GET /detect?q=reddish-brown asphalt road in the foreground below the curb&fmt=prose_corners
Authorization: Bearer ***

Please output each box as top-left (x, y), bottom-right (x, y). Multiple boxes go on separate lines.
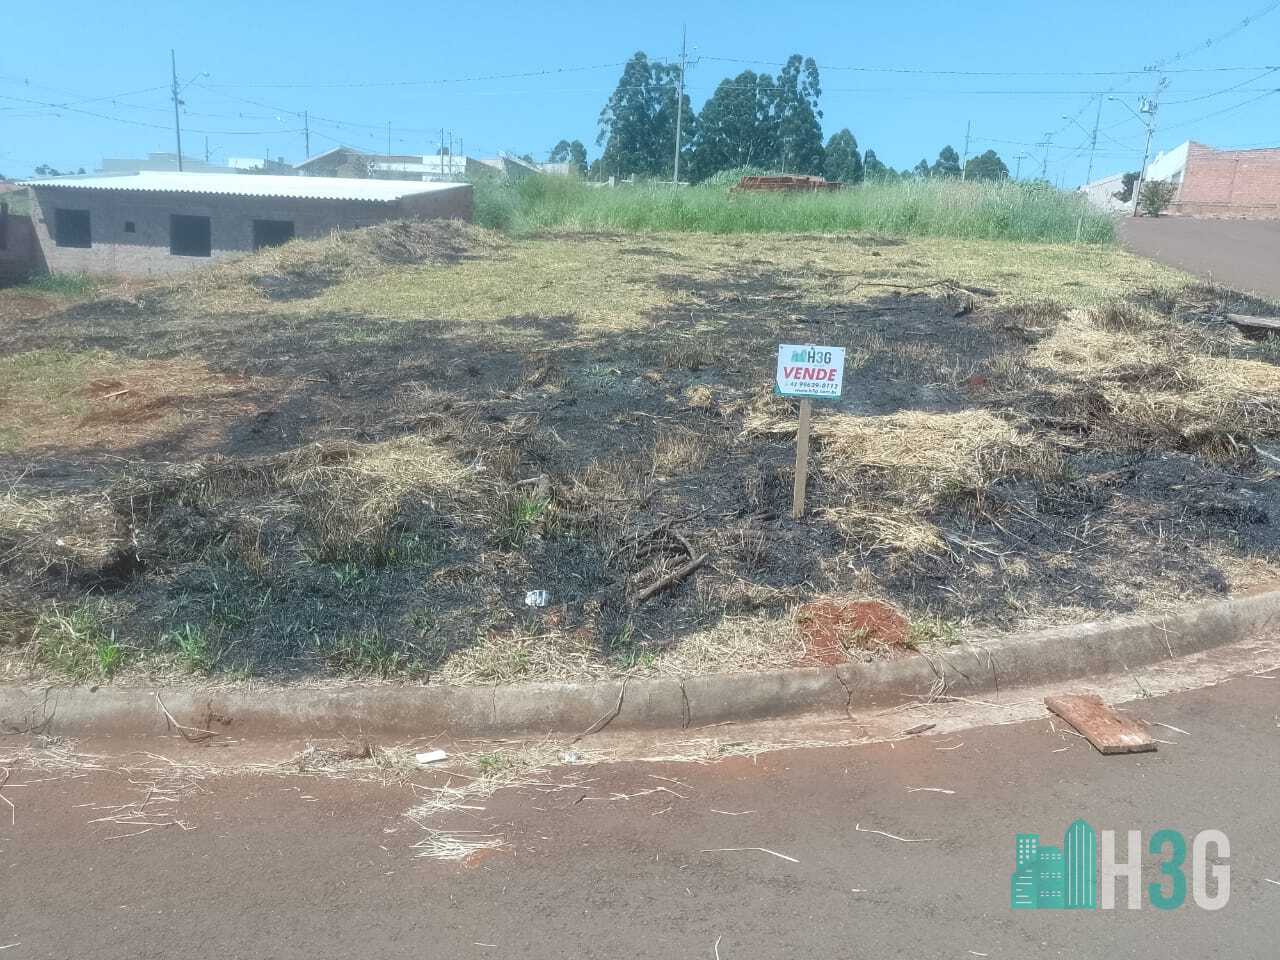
top-left (0, 676), bottom-right (1280, 960)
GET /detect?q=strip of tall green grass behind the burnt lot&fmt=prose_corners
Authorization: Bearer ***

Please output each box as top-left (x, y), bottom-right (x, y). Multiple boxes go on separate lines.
top-left (475, 177), bottom-right (1114, 243)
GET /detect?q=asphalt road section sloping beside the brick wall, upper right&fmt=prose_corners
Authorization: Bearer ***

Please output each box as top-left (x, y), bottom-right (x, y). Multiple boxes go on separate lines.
top-left (1120, 216), bottom-right (1280, 300)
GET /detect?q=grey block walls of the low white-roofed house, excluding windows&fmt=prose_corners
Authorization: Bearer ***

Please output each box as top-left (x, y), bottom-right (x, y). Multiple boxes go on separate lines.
top-left (32, 186), bottom-right (471, 276)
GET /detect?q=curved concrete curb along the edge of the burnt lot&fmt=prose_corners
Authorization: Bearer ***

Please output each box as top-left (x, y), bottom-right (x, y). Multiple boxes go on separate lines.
top-left (0, 590), bottom-right (1280, 739)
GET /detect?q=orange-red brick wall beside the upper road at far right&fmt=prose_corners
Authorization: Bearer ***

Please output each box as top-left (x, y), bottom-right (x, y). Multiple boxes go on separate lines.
top-left (1172, 143), bottom-right (1280, 218)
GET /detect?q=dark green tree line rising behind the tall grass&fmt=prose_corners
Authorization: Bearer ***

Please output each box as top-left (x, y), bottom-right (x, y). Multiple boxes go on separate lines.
top-left (550, 51), bottom-right (1009, 183)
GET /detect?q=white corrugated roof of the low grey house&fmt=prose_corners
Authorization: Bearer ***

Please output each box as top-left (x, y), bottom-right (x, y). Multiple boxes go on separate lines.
top-left (27, 170), bottom-right (463, 204)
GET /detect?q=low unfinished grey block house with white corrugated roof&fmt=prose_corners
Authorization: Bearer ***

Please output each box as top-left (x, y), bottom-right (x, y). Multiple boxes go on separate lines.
top-left (27, 172), bottom-right (471, 276)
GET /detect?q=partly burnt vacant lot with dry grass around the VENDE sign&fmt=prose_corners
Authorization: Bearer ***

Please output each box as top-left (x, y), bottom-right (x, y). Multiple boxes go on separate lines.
top-left (0, 225), bottom-right (1280, 682)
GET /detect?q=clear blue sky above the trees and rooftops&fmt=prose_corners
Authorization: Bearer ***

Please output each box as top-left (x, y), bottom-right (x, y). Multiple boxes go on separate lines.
top-left (0, 0), bottom-right (1280, 186)
